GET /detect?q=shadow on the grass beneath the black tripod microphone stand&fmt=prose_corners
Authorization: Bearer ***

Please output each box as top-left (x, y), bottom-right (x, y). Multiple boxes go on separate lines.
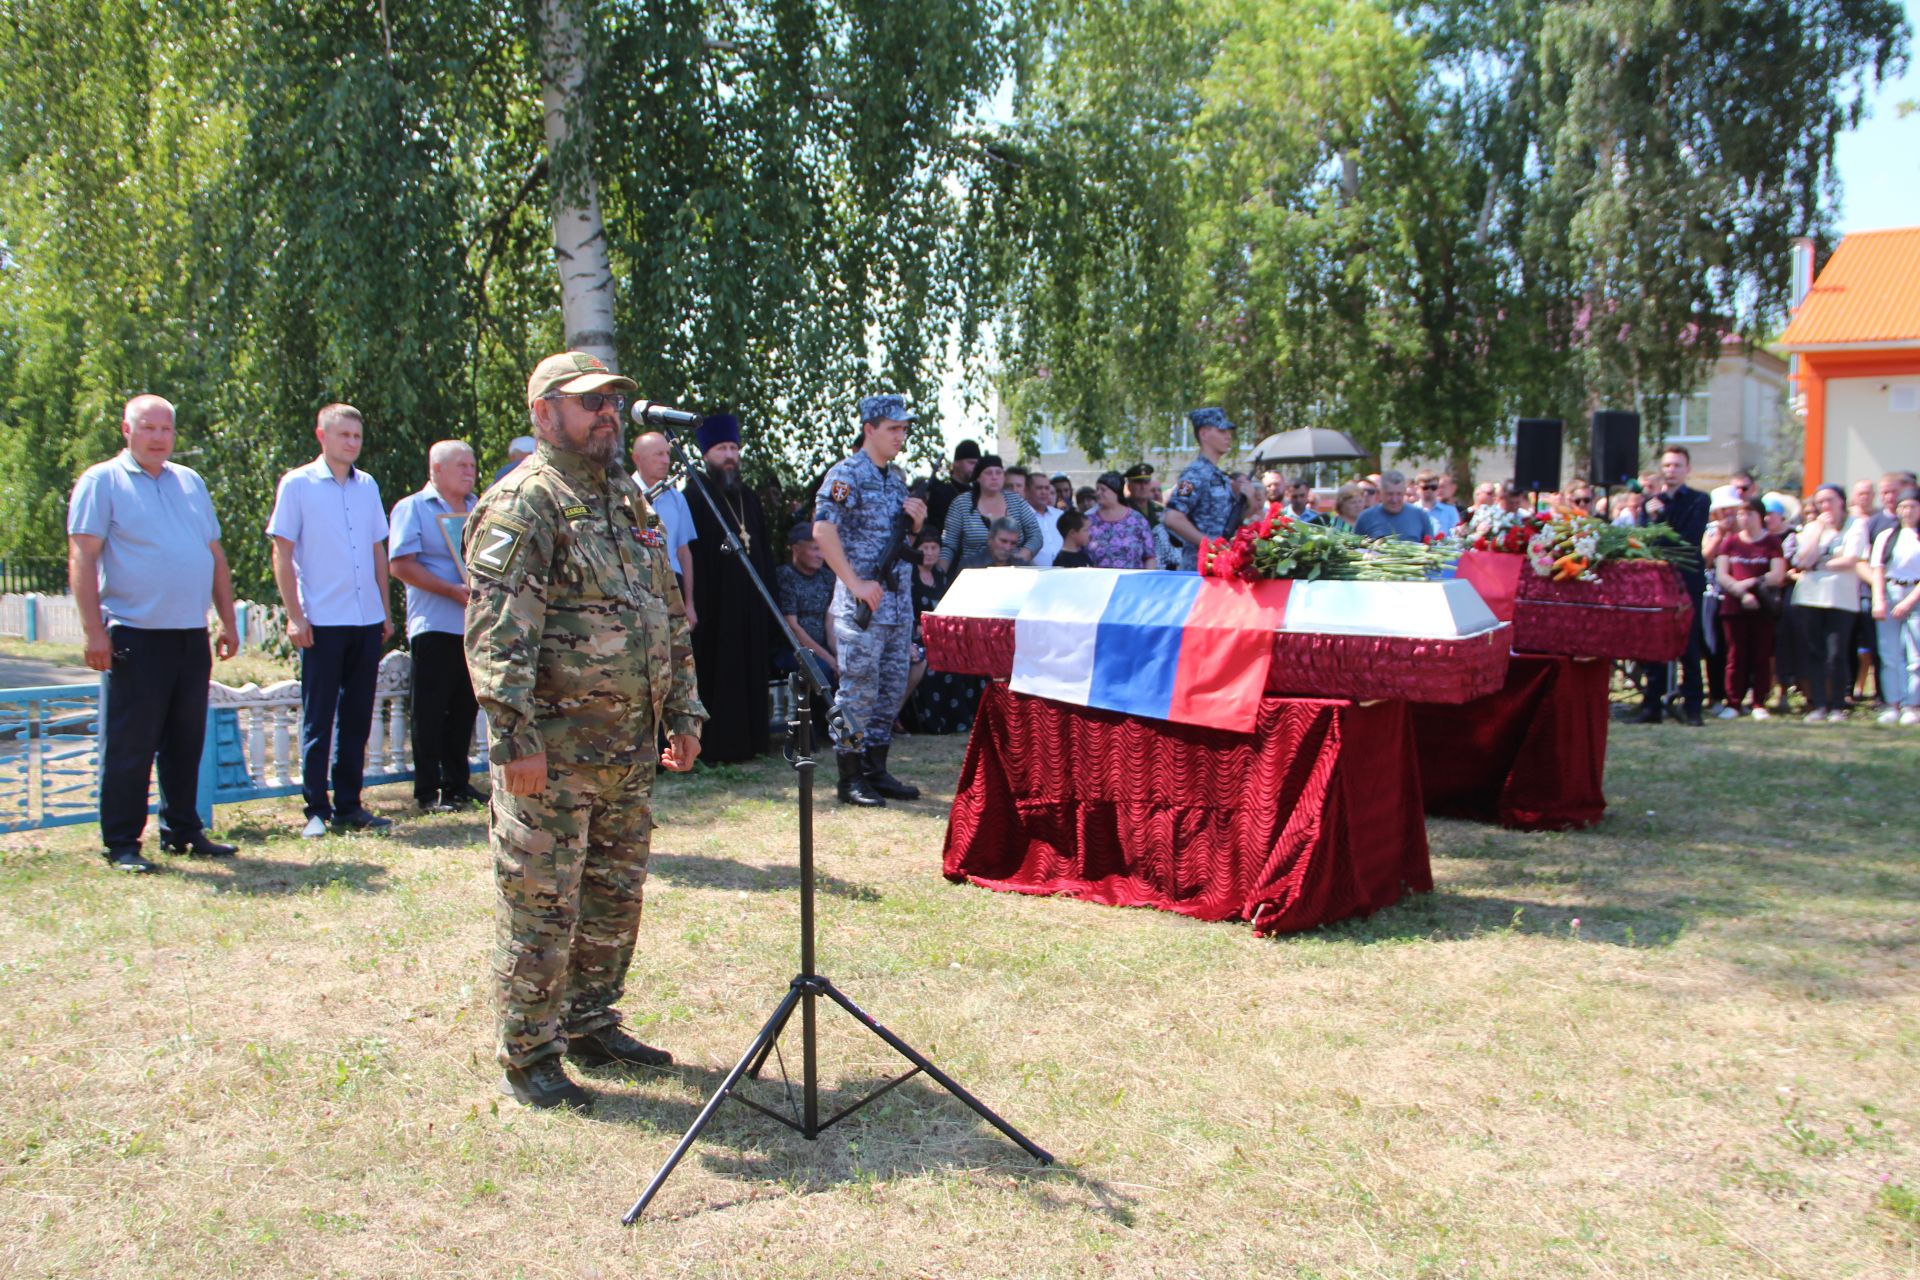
top-left (582, 1042), bottom-right (1135, 1226)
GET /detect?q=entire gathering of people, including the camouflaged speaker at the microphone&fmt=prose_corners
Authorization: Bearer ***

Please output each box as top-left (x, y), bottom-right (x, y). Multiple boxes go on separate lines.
top-left (67, 372), bottom-right (1920, 1107)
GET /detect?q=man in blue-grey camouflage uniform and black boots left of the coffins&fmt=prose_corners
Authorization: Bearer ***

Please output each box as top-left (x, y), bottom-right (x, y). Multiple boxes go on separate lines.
top-left (814, 395), bottom-right (927, 806)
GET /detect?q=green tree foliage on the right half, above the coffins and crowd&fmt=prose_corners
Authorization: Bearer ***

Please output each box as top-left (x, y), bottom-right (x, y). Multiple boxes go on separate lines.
top-left (996, 0), bottom-right (1907, 472)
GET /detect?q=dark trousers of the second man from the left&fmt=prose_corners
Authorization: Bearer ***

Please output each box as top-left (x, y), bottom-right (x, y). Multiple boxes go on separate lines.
top-left (300, 622), bottom-right (380, 821)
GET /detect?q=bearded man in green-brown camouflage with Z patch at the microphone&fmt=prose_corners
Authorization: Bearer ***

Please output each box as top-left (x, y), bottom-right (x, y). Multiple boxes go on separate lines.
top-left (465, 351), bottom-right (707, 1109)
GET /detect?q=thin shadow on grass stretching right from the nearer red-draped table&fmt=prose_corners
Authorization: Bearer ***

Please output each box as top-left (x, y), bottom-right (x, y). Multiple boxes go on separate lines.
top-left (1308, 889), bottom-right (1693, 948)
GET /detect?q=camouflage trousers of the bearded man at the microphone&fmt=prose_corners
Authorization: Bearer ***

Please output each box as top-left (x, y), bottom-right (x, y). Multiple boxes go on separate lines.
top-left (488, 756), bottom-right (655, 1067)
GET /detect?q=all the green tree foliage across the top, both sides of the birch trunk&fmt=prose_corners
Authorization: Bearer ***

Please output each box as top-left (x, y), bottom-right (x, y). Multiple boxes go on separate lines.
top-left (0, 0), bottom-right (1905, 595)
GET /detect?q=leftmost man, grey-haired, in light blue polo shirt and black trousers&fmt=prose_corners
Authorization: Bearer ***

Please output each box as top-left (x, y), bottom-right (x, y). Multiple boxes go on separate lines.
top-left (67, 395), bottom-right (238, 871)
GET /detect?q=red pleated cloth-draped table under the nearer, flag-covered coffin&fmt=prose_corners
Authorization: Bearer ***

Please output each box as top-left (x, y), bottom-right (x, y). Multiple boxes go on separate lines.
top-left (945, 681), bottom-right (1432, 935)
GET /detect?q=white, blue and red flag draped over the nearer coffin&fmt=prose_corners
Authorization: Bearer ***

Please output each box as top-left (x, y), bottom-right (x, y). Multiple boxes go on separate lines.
top-left (1010, 570), bottom-right (1294, 733)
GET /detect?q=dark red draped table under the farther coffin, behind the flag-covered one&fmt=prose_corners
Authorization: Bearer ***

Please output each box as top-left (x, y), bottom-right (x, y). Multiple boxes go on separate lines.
top-left (1413, 652), bottom-right (1613, 831)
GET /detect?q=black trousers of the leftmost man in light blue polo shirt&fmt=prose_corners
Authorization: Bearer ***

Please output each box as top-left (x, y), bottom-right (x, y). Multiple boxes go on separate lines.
top-left (100, 628), bottom-right (213, 848)
